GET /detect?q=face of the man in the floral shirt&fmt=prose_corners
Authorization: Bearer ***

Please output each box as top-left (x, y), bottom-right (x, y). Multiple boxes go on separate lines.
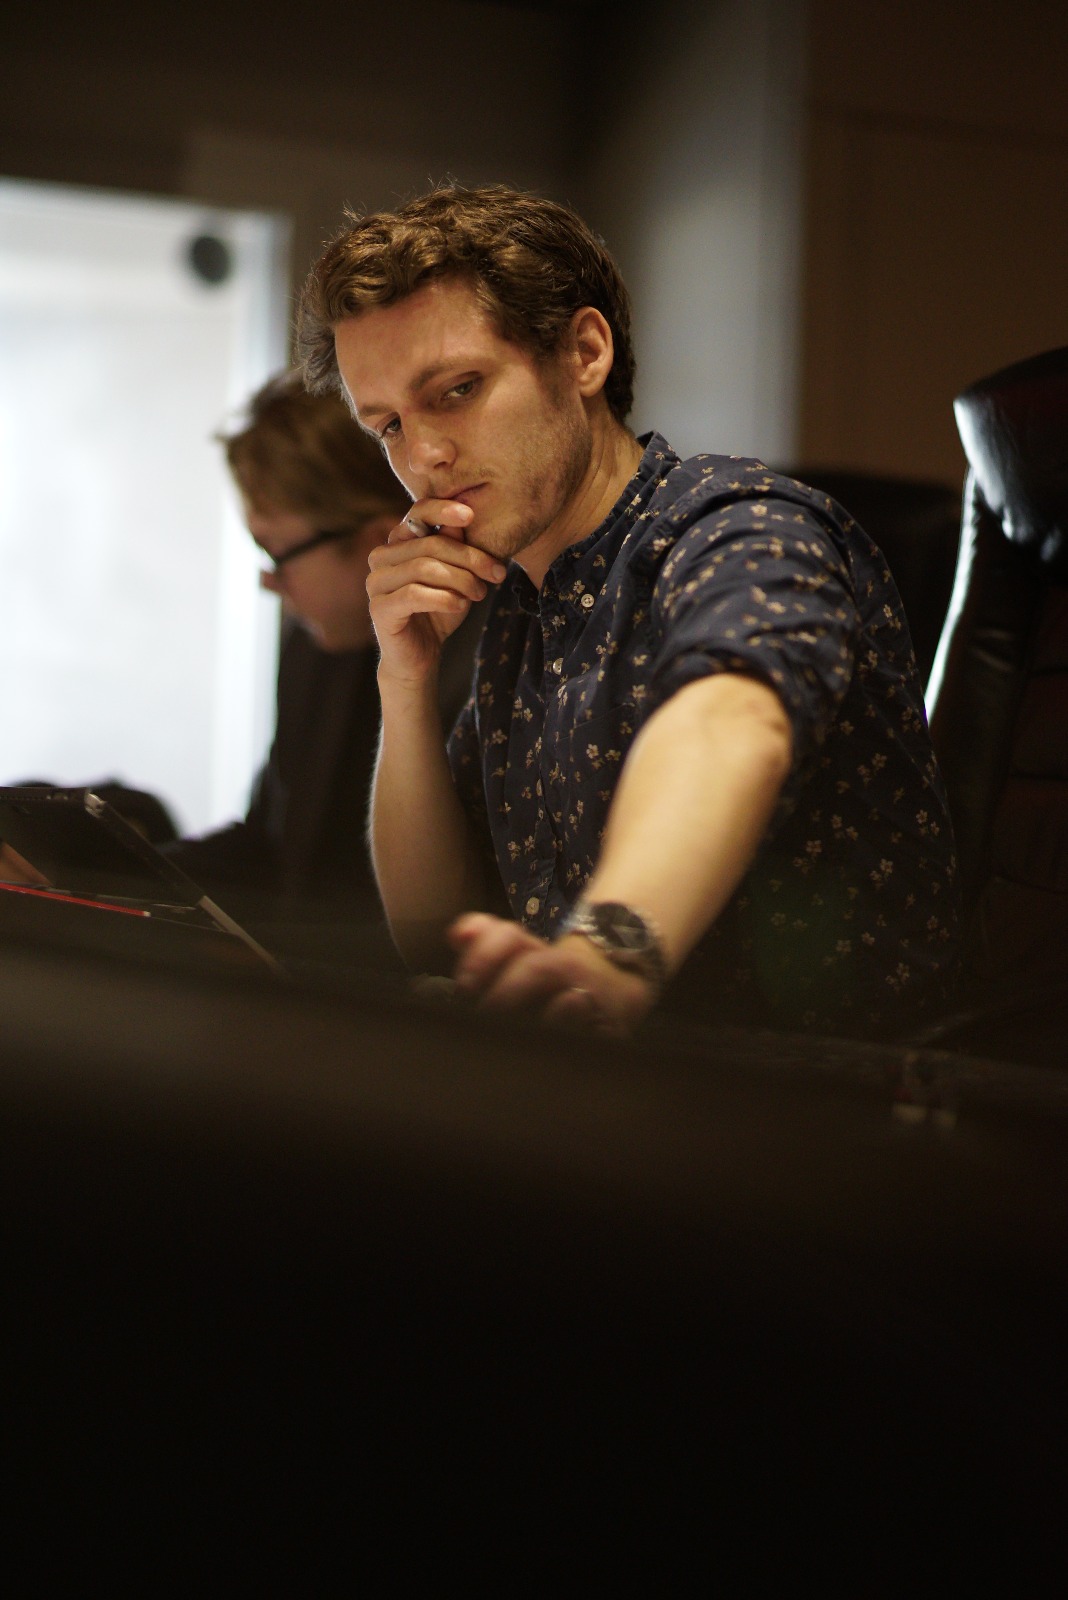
top-left (336, 280), bottom-right (592, 560)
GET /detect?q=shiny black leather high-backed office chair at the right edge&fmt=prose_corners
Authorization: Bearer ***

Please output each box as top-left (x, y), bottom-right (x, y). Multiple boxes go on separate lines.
top-left (929, 349), bottom-right (1068, 1066)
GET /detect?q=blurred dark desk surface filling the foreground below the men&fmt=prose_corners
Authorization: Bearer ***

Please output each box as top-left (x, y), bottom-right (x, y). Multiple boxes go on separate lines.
top-left (0, 942), bottom-right (1068, 1595)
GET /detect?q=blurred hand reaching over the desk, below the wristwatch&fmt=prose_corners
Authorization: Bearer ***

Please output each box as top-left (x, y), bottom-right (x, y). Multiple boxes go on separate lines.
top-left (449, 912), bottom-right (654, 1034)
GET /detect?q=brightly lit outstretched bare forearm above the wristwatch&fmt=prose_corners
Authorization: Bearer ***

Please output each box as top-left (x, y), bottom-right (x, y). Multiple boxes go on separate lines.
top-left (575, 674), bottom-right (791, 971)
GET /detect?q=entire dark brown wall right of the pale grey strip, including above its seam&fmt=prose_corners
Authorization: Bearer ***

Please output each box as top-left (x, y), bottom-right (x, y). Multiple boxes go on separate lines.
top-left (799, 0), bottom-right (1068, 488)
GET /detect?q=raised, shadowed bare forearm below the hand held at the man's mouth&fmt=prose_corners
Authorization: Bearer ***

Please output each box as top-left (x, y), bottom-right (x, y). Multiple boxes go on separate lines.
top-left (371, 683), bottom-right (488, 968)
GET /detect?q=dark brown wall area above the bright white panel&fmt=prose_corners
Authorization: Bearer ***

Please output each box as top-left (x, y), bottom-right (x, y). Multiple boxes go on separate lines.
top-left (0, 0), bottom-right (593, 297)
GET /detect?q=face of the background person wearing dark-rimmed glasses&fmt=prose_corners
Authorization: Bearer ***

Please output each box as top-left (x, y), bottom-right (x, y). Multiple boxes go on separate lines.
top-left (245, 498), bottom-right (382, 651)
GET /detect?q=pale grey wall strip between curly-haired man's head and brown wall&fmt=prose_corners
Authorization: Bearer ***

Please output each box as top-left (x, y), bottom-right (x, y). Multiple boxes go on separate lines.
top-left (574, 0), bottom-right (804, 462)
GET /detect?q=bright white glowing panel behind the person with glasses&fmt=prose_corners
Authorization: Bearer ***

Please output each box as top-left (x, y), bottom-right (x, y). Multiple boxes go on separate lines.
top-left (0, 182), bottom-right (286, 832)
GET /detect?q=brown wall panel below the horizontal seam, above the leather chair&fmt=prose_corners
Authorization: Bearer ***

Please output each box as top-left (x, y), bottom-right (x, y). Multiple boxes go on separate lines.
top-left (801, 114), bottom-right (1068, 483)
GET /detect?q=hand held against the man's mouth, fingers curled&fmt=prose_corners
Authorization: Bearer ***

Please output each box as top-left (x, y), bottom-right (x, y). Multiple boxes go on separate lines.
top-left (368, 499), bottom-right (507, 683)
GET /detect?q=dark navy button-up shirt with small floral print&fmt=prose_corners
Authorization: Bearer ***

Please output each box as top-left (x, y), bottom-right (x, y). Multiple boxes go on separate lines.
top-left (449, 434), bottom-right (958, 1034)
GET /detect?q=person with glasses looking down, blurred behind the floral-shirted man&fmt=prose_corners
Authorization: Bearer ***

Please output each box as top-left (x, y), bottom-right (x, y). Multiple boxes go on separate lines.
top-left (166, 373), bottom-right (476, 954)
